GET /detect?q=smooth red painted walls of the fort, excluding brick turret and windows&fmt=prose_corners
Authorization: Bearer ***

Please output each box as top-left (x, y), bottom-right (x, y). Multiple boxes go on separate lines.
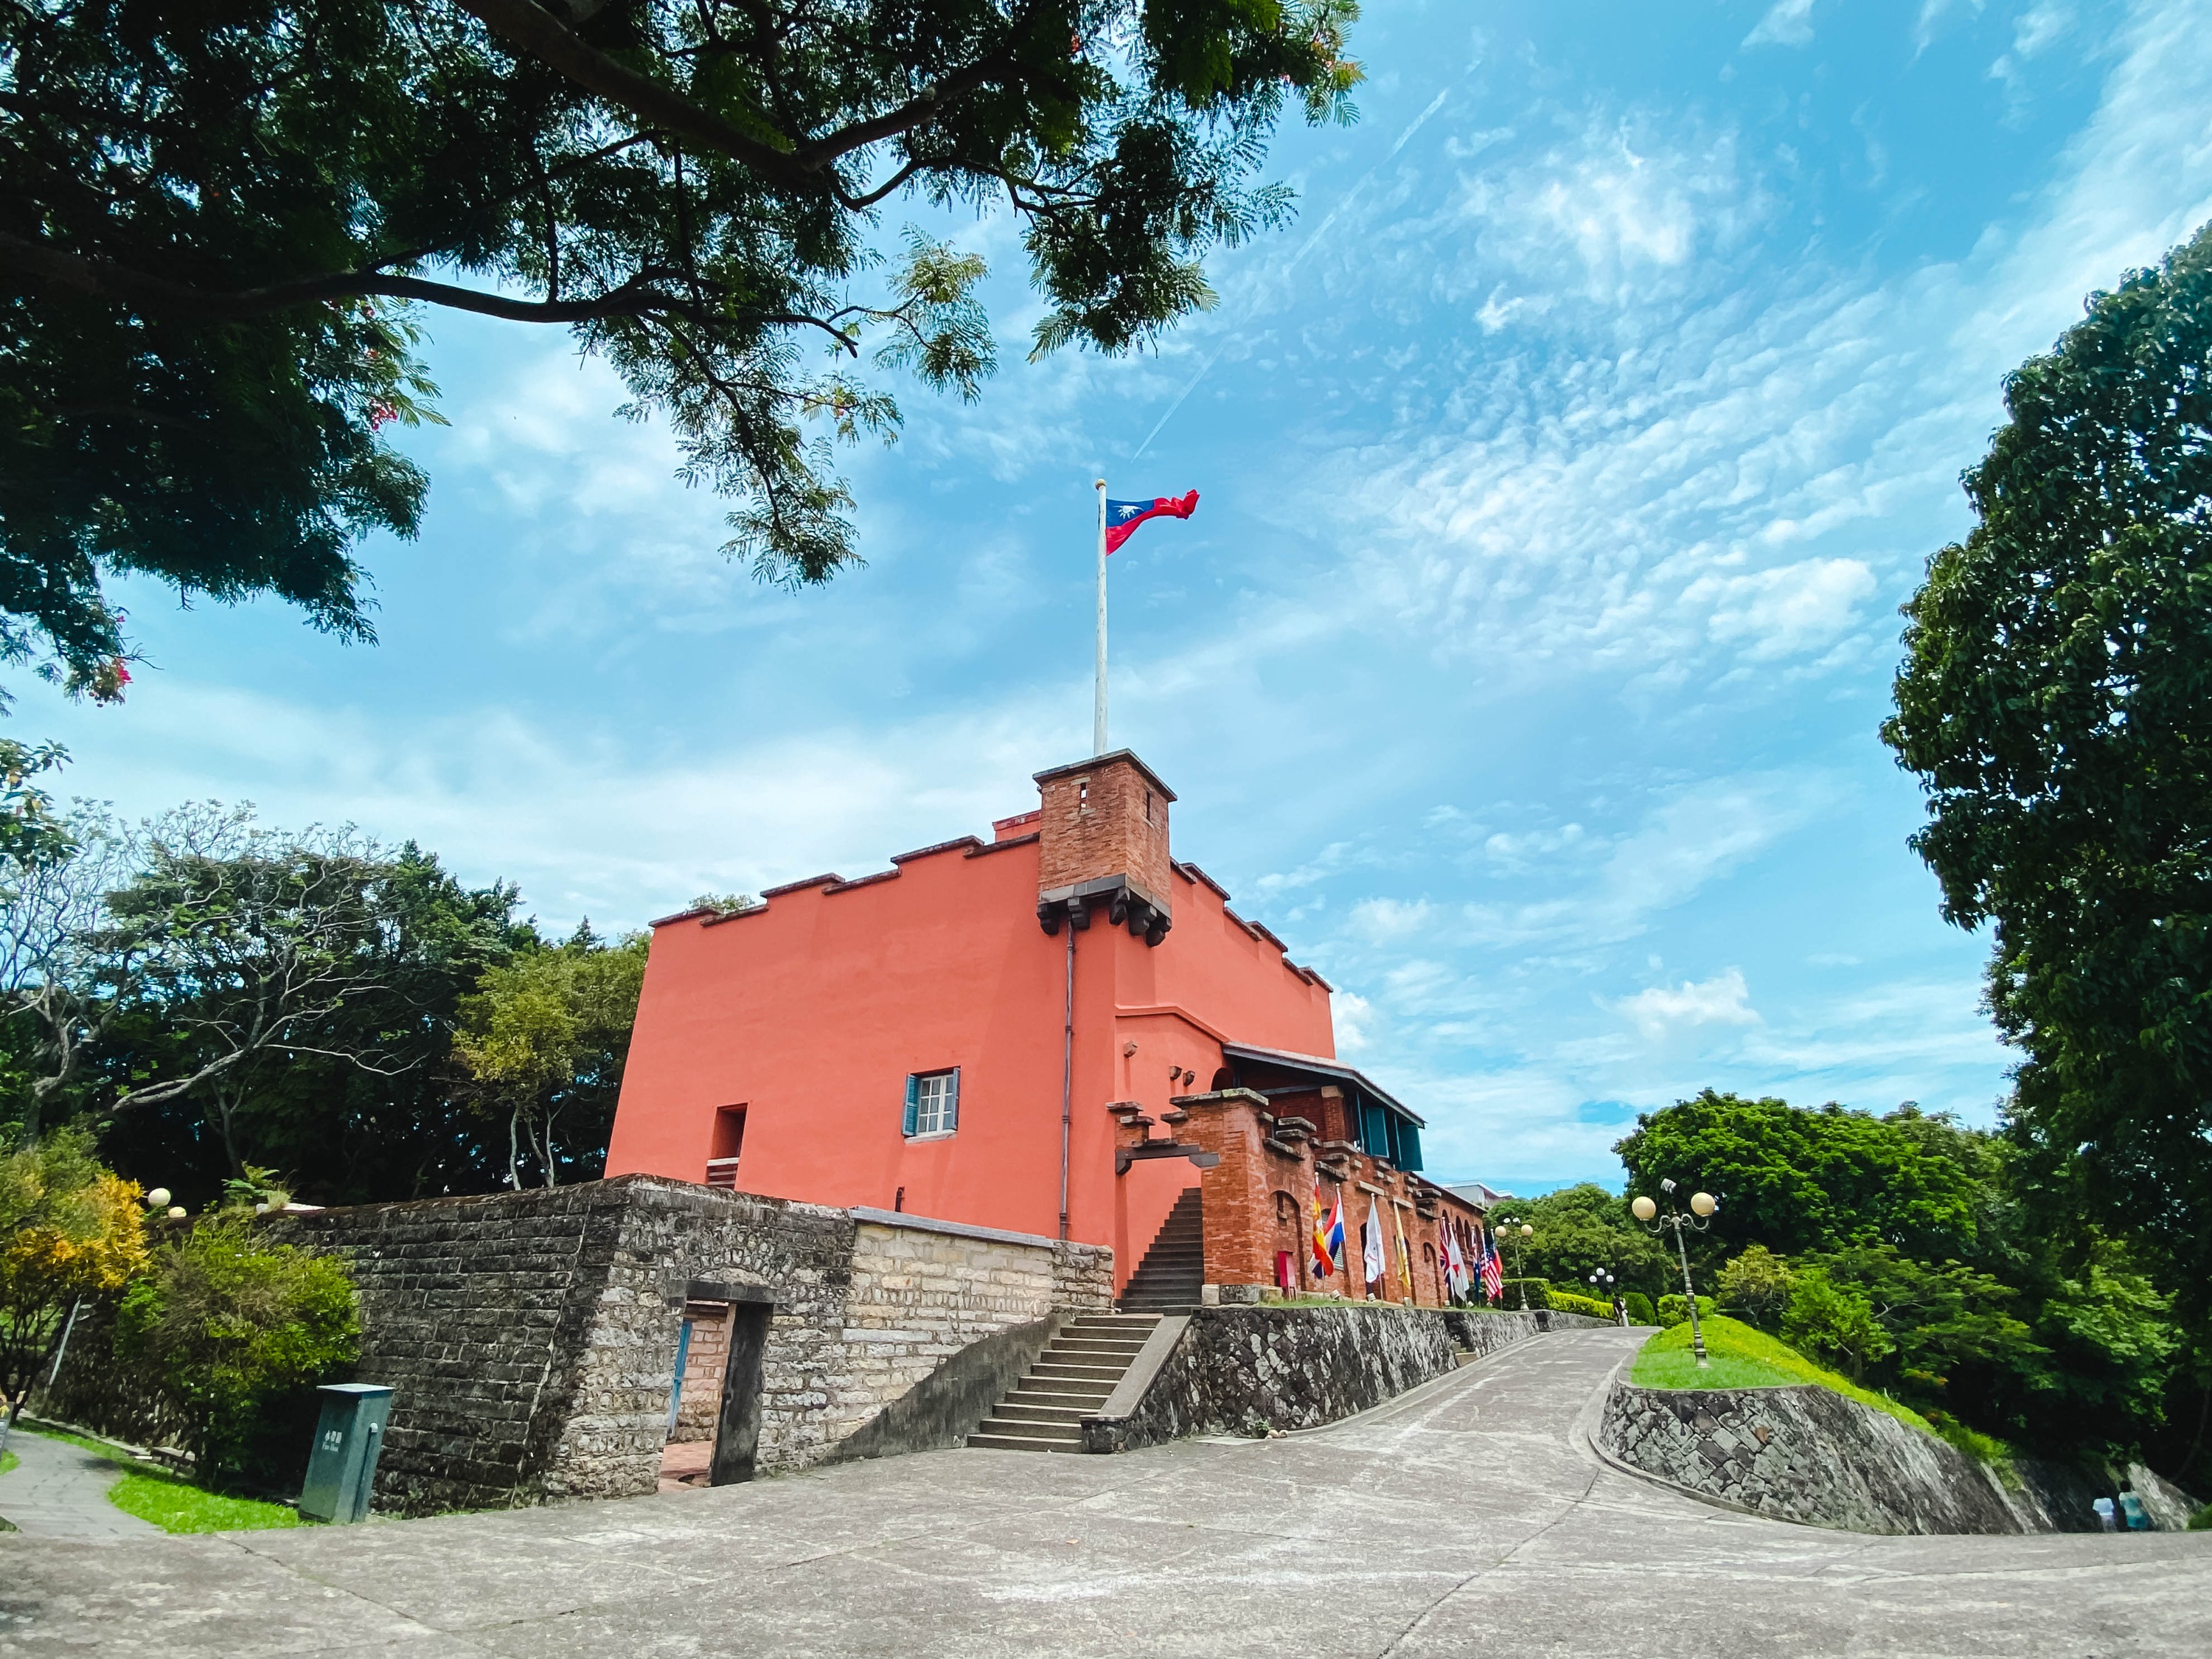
top-left (606, 818), bottom-right (1334, 1281)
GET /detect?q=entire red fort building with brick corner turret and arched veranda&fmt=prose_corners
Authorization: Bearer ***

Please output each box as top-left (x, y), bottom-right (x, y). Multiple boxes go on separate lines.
top-left (606, 750), bottom-right (1480, 1303)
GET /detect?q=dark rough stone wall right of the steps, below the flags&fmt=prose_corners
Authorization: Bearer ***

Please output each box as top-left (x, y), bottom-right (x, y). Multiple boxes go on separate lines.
top-left (1086, 1303), bottom-right (1573, 1451)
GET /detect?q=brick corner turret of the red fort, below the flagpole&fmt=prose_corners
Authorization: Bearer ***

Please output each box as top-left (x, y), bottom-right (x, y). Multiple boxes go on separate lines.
top-left (1037, 750), bottom-right (1175, 945)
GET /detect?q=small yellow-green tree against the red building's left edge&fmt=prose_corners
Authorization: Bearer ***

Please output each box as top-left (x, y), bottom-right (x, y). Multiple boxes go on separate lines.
top-left (453, 922), bottom-right (646, 1188)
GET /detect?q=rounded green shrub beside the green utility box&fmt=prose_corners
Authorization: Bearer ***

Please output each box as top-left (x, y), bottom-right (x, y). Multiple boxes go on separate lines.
top-left (115, 1217), bottom-right (361, 1491)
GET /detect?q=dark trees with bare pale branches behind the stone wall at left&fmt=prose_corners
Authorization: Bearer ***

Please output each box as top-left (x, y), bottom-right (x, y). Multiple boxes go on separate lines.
top-left (94, 810), bottom-right (544, 1208)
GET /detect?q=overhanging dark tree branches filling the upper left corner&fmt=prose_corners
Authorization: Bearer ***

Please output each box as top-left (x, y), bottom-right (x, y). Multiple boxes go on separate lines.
top-left (0, 0), bottom-right (1358, 695)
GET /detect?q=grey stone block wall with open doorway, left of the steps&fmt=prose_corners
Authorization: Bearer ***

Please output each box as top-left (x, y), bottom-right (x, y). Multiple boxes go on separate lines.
top-left (34, 1175), bottom-right (1113, 1513)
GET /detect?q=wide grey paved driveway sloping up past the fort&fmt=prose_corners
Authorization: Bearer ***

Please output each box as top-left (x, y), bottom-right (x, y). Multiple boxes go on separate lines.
top-left (0, 1329), bottom-right (2212, 1659)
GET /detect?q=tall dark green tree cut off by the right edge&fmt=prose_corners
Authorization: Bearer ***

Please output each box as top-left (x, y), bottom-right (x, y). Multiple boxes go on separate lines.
top-left (1882, 228), bottom-right (2212, 1329)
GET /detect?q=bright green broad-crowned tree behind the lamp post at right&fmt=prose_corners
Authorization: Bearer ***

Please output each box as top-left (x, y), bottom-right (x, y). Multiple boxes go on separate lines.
top-left (1615, 1088), bottom-right (1982, 1272)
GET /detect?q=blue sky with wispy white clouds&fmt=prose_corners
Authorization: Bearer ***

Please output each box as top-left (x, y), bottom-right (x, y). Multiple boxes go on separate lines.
top-left (26, 0), bottom-right (2212, 1192)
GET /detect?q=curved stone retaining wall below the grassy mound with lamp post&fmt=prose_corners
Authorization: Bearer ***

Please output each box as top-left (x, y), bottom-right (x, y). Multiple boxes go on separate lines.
top-left (1597, 1380), bottom-right (2192, 1533)
